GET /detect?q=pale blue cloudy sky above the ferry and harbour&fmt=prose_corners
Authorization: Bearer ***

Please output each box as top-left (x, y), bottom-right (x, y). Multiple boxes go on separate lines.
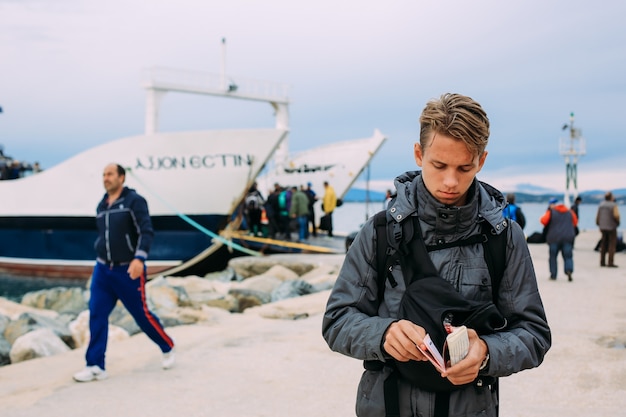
top-left (0, 0), bottom-right (626, 195)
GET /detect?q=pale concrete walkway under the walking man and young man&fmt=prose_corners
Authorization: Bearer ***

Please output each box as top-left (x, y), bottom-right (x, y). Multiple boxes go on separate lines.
top-left (0, 232), bottom-right (626, 417)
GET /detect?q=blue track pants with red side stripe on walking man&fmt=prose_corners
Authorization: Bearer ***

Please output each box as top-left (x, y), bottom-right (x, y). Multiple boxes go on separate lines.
top-left (85, 262), bottom-right (174, 369)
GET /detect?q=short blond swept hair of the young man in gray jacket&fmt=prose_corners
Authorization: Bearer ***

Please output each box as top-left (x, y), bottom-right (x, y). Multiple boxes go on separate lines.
top-left (420, 93), bottom-right (489, 156)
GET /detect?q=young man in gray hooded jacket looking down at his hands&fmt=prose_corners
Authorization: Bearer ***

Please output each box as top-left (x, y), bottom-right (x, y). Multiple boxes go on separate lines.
top-left (322, 94), bottom-right (551, 417)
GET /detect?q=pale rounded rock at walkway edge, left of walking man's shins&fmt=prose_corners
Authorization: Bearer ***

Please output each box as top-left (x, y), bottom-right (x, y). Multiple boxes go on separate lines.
top-left (10, 328), bottom-right (70, 363)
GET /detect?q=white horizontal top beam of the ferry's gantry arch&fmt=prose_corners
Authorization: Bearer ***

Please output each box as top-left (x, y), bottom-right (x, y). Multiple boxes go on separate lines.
top-left (143, 67), bottom-right (290, 102)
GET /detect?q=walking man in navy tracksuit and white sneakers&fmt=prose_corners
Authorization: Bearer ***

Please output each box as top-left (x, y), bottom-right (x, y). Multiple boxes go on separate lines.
top-left (74, 164), bottom-right (174, 382)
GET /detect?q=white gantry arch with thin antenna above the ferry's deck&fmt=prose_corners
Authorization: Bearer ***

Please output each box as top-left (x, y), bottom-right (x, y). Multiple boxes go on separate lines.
top-left (143, 38), bottom-right (290, 169)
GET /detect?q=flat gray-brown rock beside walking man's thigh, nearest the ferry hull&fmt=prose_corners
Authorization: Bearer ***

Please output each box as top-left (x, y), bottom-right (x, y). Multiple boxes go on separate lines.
top-left (21, 287), bottom-right (87, 315)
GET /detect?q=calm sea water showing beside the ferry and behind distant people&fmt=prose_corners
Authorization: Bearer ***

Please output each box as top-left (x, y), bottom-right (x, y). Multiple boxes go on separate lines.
top-left (0, 201), bottom-right (626, 302)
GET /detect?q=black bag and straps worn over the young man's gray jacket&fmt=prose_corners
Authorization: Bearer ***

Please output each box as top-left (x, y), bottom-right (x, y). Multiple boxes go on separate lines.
top-left (364, 211), bottom-right (507, 416)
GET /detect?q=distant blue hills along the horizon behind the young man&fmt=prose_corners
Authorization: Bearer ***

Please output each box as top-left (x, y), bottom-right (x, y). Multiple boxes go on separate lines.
top-left (343, 188), bottom-right (626, 204)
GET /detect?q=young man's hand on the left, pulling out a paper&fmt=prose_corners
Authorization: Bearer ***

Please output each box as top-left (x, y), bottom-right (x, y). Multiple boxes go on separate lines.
top-left (383, 320), bottom-right (428, 362)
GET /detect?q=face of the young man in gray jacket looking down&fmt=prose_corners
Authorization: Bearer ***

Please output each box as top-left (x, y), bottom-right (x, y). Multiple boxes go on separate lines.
top-left (414, 133), bottom-right (487, 206)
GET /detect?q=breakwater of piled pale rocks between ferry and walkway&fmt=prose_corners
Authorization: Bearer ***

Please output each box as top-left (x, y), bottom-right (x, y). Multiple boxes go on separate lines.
top-left (0, 255), bottom-right (343, 366)
